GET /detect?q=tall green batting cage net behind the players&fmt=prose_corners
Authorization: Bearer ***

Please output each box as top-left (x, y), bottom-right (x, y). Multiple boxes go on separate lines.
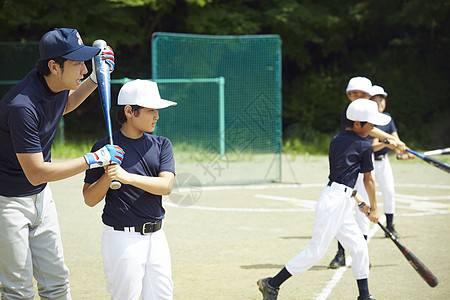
top-left (152, 32), bottom-right (282, 185)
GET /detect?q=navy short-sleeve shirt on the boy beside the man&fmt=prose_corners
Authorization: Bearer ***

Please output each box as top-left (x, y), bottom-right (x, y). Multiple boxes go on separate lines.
top-left (84, 131), bottom-right (175, 227)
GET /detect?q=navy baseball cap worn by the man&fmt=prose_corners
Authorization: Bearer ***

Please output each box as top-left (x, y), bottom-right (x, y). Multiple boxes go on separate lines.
top-left (39, 28), bottom-right (100, 61)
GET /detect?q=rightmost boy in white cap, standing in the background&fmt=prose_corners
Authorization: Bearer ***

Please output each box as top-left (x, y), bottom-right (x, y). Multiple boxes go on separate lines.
top-left (371, 85), bottom-right (414, 238)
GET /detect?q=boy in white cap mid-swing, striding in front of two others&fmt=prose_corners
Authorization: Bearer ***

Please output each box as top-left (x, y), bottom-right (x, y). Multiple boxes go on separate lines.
top-left (257, 99), bottom-right (390, 300)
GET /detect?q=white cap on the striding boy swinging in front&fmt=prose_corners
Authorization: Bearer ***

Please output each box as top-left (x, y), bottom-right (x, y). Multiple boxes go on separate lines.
top-left (346, 99), bottom-right (391, 125)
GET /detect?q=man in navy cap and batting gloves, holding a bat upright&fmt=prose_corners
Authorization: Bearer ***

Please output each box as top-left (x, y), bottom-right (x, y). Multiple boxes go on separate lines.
top-left (0, 28), bottom-right (123, 299)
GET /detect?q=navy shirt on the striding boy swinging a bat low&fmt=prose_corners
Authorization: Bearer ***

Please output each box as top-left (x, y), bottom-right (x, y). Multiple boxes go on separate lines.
top-left (328, 130), bottom-right (373, 188)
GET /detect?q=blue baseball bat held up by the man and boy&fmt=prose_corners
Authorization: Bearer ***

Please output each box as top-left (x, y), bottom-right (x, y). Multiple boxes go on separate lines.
top-left (92, 40), bottom-right (122, 190)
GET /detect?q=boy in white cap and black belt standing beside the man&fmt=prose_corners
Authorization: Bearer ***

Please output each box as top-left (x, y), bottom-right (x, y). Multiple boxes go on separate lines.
top-left (83, 80), bottom-right (176, 300)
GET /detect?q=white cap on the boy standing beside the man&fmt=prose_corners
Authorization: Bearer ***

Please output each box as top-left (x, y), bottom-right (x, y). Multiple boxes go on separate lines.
top-left (117, 79), bottom-right (177, 109)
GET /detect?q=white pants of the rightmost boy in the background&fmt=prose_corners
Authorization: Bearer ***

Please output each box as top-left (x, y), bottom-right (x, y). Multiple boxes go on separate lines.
top-left (374, 155), bottom-right (395, 214)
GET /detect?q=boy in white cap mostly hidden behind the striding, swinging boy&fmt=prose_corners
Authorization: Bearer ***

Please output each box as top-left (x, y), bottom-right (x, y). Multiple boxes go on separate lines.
top-left (329, 77), bottom-right (405, 269)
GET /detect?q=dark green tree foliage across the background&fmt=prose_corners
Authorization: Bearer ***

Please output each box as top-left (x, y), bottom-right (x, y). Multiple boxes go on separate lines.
top-left (0, 0), bottom-right (450, 148)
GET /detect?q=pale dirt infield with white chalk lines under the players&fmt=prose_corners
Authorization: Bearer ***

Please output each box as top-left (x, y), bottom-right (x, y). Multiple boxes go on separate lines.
top-left (44, 156), bottom-right (450, 300)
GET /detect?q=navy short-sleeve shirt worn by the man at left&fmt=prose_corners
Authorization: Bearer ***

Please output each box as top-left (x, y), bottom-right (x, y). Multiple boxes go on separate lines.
top-left (0, 69), bottom-right (69, 197)
